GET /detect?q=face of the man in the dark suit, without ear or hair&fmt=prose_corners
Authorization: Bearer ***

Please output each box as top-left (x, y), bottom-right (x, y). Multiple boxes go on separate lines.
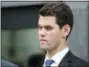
top-left (38, 16), bottom-right (62, 50)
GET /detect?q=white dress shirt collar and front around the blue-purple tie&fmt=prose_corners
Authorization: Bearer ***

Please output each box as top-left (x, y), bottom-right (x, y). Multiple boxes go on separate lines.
top-left (43, 47), bottom-right (69, 67)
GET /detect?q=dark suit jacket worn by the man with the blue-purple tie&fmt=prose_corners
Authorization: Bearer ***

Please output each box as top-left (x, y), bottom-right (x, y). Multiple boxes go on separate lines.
top-left (28, 51), bottom-right (89, 67)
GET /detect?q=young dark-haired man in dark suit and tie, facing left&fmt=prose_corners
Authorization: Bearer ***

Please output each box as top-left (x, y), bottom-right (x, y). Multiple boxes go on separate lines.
top-left (29, 2), bottom-right (88, 67)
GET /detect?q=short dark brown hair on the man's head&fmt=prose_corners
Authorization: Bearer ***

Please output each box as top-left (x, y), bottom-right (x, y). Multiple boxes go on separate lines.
top-left (39, 2), bottom-right (73, 38)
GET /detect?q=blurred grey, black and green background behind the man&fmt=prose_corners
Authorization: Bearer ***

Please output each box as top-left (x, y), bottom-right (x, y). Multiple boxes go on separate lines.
top-left (1, 0), bottom-right (89, 67)
